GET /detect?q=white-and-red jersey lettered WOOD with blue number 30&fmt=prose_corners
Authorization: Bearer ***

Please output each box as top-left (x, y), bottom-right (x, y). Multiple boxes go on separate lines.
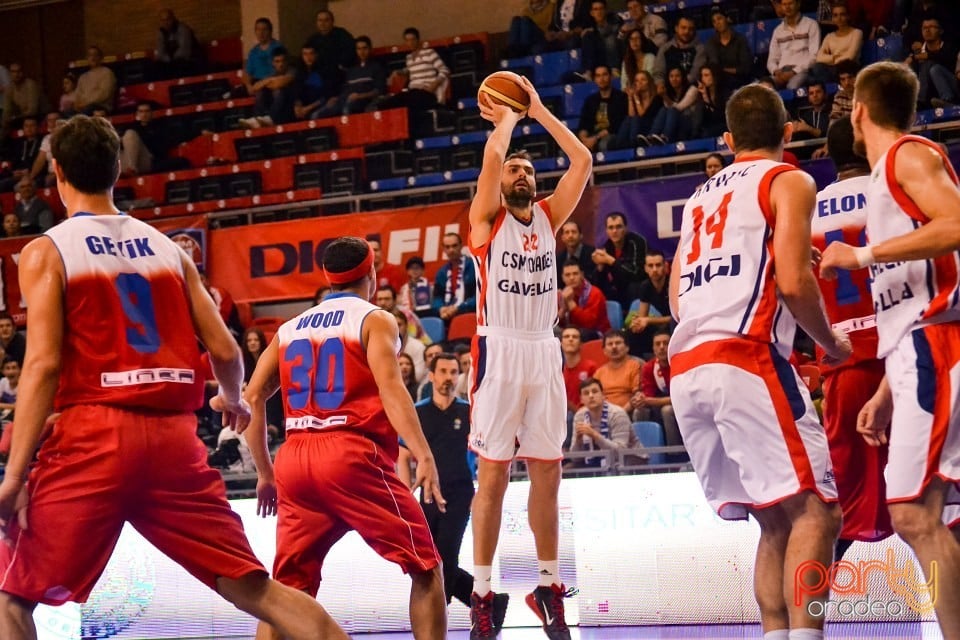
top-left (277, 293), bottom-right (400, 459)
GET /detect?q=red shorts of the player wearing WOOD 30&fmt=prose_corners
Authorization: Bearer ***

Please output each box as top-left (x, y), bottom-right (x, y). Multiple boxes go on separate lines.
top-left (273, 431), bottom-right (440, 595)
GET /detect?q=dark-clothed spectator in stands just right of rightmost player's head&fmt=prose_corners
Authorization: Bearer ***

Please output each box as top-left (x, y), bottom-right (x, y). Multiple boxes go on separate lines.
top-left (904, 18), bottom-right (960, 107)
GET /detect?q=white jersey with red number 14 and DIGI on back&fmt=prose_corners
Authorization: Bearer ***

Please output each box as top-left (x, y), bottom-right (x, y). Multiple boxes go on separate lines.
top-left (670, 156), bottom-right (796, 357)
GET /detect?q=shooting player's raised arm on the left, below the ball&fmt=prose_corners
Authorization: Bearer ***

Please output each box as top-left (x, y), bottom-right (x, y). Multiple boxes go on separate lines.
top-left (470, 76), bottom-right (523, 247)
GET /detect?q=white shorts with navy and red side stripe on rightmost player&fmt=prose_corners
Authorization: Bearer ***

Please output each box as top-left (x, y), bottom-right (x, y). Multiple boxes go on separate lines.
top-left (886, 323), bottom-right (960, 504)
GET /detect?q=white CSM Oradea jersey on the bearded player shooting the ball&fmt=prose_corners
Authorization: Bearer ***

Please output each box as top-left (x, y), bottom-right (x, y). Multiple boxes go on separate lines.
top-left (471, 202), bottom-right (557, 333)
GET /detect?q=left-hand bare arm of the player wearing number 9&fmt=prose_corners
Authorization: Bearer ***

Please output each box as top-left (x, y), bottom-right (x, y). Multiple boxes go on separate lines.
top-left (0, 237), bottom-right (65, 524)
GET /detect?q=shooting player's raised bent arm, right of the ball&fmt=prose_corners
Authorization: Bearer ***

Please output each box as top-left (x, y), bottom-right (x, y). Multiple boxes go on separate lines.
top-left (520, 78), bottom-right (593, 233)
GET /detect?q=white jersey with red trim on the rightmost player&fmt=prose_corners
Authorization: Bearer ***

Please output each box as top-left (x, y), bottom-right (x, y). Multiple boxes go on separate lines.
top-left (867, 136), bottom-right (960, 358)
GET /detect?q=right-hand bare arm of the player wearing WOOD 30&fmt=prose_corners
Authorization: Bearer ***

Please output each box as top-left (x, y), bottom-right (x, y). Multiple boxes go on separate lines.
top-left (361, 311), bottom-right (447, 511)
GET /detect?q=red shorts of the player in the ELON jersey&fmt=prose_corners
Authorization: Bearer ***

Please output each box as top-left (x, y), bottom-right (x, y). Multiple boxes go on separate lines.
top-left (823, 359), bottom-right (893, 542)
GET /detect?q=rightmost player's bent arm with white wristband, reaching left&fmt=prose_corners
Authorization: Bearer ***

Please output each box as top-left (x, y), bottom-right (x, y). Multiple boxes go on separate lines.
top-left (820, 142), bottom-right (960, 277)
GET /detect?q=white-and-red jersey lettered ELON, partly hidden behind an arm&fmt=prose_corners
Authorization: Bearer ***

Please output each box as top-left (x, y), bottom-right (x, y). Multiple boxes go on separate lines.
top-left (811, 176), bottom-right (877, 373)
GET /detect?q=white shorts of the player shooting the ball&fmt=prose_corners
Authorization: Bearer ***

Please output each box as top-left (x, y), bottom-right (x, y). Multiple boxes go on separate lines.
top-left (470, 327), bottom-right (567, 462)
